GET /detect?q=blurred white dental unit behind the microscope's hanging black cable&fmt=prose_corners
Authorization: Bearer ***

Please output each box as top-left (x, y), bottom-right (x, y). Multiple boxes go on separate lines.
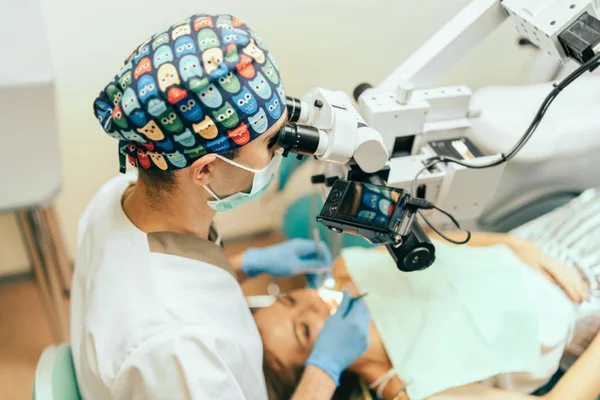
top-left (470, 75), bottom-right (600, 232)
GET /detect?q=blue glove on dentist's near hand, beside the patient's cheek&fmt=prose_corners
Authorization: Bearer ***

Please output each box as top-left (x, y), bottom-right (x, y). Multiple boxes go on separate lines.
top-left (306, 291), bottom-right (371, 385)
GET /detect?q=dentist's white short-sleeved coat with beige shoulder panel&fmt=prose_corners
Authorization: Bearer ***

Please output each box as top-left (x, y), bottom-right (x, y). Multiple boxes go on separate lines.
top-left (71, 176), bottom-right (267, 400)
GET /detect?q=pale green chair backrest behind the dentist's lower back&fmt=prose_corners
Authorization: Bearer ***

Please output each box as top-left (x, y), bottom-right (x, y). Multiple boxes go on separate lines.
top-left (32, 343), bottom-right (81, 400)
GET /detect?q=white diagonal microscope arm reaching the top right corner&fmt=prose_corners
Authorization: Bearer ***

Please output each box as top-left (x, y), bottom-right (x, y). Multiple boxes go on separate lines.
top-left (374, 0), bottom-right (600, 96)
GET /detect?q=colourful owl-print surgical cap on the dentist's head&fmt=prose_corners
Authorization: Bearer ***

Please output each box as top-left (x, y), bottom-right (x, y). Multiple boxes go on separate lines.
top-left (94, 14), bottom-right (285, 172)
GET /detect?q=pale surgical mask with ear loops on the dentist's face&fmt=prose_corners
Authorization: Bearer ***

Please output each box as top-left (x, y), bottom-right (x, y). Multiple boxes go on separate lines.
top-left (204, 150), bottom-right (283, 212)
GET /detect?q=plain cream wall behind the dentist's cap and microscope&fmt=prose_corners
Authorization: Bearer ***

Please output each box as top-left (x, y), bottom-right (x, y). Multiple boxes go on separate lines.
top-left (0, 0), bottom-right (532, 276)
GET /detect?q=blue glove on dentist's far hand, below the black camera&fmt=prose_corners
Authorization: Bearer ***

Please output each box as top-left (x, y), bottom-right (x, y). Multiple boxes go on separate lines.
top-left (242, 239), bottom-right (332, 278)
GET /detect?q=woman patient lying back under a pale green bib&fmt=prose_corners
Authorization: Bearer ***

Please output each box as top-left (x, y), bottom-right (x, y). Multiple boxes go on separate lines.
top-left (254, 233), bottom-right (600, 400)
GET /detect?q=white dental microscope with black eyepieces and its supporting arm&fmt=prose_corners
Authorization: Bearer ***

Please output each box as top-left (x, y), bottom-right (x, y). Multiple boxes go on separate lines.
top-left (274, 0), bottom-right (600, 270)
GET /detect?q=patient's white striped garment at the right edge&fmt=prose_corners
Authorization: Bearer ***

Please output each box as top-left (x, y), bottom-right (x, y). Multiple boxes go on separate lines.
top-left (512, 189), bottom-right (600, 365)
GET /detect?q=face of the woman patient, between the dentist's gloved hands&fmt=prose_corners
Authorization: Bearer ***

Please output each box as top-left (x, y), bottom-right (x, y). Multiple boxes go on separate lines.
top-left (254, 289), bottom-right (329, 375)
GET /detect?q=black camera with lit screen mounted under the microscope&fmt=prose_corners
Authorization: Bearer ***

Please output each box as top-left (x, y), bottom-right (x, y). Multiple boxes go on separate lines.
top-left (317, 180), bottom-right (435, 272)
